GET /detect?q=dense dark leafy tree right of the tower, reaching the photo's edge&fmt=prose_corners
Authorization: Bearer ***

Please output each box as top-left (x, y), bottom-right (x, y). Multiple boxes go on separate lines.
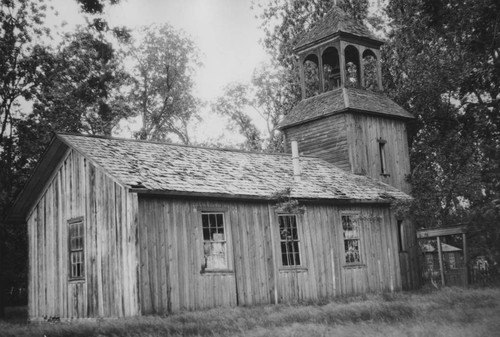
top-left (383, 0), bottom-right (500, 258)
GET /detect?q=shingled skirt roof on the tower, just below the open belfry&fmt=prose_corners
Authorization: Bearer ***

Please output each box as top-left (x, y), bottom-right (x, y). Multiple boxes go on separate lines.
top-left (279, 88), bottom-right (414, 129)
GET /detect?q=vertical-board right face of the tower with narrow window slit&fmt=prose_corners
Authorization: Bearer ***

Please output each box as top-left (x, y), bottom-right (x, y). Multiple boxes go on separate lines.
top-left (346, 114), bottom-right (411, 193)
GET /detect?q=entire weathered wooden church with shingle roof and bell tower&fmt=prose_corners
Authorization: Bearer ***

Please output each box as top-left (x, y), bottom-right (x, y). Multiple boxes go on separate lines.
top-left (9, 5), bottom-right (415, 320)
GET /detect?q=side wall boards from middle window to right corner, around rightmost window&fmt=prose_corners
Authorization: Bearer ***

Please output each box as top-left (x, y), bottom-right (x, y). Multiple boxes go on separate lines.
top-left (272, 205), bottom-right (401, 301)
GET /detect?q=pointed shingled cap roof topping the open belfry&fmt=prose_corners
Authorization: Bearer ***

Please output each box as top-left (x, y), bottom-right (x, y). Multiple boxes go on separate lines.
top-left (294, 6), bottom-right (383, 51)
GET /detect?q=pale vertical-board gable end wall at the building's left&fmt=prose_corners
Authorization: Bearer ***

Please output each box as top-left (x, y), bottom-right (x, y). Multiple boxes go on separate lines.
top-left (28, 151), bottom-right (139, 319)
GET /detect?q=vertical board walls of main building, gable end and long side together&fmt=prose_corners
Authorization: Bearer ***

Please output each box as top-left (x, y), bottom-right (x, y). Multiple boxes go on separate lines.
top-left (27, 147), bottom-right (408, 319)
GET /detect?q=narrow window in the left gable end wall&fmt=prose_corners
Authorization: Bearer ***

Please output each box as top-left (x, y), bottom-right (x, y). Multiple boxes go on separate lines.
top-left (68, 218), bottom-right (85, 279)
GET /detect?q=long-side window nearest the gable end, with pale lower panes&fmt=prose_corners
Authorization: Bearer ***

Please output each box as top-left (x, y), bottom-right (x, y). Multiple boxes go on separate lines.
top-left (201, 212), bottom-right (227, 270)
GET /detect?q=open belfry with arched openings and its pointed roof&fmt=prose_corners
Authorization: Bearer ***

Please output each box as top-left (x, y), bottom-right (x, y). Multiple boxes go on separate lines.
top-left (294, 6), bottom-right (383, 99)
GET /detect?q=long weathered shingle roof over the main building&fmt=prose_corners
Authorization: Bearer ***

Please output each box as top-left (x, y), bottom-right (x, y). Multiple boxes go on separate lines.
top-left (62, 134), bottom-right (409, 202)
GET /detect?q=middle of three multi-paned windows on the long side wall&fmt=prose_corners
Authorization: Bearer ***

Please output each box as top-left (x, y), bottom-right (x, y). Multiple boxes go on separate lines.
top-left (278, 215), bottom-right (300, 267)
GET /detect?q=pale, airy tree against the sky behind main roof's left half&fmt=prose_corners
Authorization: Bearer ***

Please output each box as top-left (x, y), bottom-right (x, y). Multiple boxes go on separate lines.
top-left (130, 24), bottom-right (201, 144)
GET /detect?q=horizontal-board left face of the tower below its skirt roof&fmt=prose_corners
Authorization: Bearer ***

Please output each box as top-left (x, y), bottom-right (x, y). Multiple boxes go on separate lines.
top-left (284, 114), bottom-right (351, 171)
